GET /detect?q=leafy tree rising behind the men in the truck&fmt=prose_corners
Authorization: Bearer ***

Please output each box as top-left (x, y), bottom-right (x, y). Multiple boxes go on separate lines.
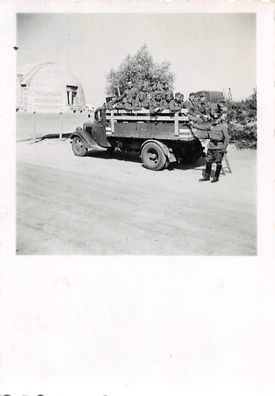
top-left (106, 44), bottom-right (174, 95)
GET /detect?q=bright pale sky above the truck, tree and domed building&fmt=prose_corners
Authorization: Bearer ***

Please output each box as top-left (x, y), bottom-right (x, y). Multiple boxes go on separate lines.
top-left (17, 13), bottom-right (256, 105)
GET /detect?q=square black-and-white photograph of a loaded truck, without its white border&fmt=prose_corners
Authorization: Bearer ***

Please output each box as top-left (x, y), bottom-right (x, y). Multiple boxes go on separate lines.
top-left (15, 13), bottom-right (257, 256)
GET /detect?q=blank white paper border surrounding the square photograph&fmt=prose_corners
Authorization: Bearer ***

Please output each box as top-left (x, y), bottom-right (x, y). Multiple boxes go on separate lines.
top-left (0, 1), bottom-right (275, 396)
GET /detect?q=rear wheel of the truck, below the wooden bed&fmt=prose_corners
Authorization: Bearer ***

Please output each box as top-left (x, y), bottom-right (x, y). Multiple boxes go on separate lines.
top-left (141, 142), bottom-right (168, 171)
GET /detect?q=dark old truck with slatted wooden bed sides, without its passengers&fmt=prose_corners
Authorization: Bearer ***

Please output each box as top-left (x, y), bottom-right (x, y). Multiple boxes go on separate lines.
top-left (71, 106), bottom-right (203, 171)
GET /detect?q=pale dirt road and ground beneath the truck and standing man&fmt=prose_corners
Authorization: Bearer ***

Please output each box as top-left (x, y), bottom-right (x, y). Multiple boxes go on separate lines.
top-left (17, 140), bottom-right (256, 255)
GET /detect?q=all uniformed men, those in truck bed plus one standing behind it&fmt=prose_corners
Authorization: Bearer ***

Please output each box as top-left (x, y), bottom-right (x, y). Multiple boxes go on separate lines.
top-left (107, 81), bottom-right (230, 182)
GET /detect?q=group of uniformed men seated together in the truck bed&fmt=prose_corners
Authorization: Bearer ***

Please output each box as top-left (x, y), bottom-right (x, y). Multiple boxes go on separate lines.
top-left (107, 81), bottom-right (225, 123)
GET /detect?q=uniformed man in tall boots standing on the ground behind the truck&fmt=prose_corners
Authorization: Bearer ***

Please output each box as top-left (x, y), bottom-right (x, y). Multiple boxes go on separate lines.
top-left (196, 113), bottom-right (230, 183)
